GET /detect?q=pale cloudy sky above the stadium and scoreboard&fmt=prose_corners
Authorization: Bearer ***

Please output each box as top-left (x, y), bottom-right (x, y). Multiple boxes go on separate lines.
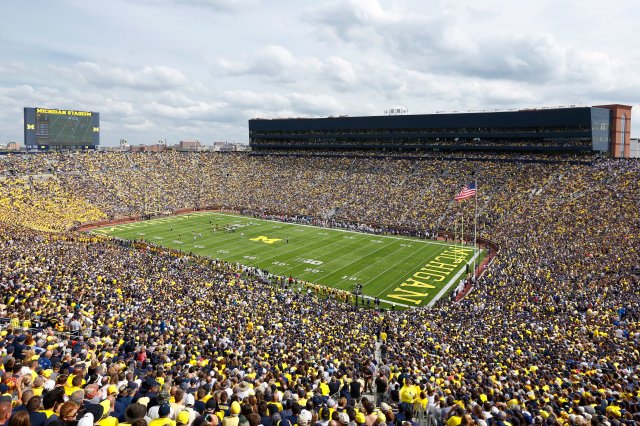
top-left (0, 0), bottom-right (640, 146)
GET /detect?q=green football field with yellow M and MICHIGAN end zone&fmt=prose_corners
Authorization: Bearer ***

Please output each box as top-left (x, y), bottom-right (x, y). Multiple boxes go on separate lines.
top-left (93, 212), bottom-right (484, 308)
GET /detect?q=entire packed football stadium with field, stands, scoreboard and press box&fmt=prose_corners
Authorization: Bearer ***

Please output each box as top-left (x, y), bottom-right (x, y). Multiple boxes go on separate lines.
top-left (0, 104), bottom-right (640, 426)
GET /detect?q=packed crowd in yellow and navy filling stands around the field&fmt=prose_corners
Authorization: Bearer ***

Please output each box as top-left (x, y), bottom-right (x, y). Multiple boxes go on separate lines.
top-left (0, 153), bottom-right (640, 426)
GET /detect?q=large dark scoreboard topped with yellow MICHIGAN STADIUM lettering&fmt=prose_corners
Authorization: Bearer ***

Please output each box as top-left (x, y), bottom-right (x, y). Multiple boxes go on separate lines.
top-left (24, 107), bottom-right (100, 150)
